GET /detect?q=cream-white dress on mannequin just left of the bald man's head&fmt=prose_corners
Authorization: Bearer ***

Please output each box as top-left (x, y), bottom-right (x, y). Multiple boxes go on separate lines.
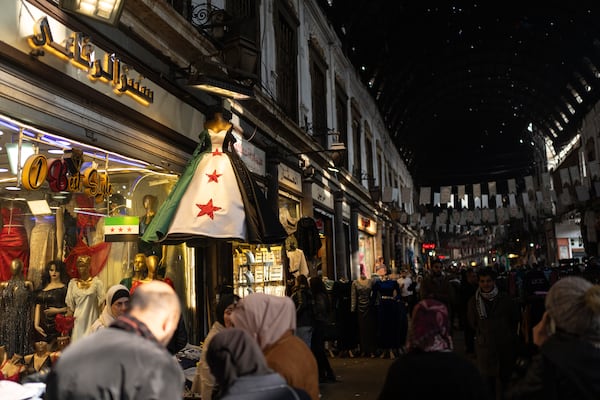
top-left (65, 277), bottom-right (104, 343)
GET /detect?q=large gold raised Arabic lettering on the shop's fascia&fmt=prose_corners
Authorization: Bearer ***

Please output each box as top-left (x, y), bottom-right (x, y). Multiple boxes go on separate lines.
top-left (27, 17), bottom-right (154, 106)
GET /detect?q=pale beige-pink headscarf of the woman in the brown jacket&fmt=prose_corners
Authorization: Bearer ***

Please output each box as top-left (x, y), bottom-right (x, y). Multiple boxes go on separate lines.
top-left (231, 293), bottom-right (296, 350)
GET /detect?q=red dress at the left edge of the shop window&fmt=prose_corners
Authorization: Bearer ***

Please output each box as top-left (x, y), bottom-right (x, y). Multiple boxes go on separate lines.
top-left (0, 207), bottom-right (29, 282)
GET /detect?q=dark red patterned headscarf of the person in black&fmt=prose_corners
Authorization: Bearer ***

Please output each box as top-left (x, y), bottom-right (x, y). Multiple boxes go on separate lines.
top-left (407, 299), bottom-right (453, 352)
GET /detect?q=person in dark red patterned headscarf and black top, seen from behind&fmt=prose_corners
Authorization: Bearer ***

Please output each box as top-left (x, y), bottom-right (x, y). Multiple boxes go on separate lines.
top-left (378, 299), bottom-right (488, 400)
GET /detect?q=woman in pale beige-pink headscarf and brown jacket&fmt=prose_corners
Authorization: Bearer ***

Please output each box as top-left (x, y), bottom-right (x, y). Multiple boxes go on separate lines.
top-left (231, 293), bottom-right (319, 400)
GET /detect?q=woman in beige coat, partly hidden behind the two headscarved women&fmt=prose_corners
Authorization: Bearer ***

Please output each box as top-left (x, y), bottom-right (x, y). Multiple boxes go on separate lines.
top-left (192, 293), bottom-right (240, 400)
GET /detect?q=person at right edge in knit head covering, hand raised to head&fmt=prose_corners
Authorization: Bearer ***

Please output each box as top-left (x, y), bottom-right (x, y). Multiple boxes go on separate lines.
top-left (506, 276), bottom-right (600, 400)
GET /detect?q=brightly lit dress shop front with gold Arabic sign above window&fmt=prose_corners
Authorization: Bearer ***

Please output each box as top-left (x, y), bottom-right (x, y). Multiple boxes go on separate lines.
top-left (0, 1), bottom-right (204, 354)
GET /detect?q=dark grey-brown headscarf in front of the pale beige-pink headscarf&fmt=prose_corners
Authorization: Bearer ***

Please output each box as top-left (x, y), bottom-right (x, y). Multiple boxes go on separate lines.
top-left (206, 328), bottom-right (273, 391)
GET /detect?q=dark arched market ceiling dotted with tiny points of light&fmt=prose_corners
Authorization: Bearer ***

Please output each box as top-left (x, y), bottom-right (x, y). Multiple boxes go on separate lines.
top-left (321, 0), bottom-right (600, 186)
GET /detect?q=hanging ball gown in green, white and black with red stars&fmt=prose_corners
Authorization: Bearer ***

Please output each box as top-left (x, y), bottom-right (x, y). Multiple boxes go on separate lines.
top-left (142, 128), bottom-right (287, 247)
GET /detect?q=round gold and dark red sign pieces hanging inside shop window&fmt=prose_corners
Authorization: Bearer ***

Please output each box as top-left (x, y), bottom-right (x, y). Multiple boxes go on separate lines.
top-left (21, 149), bottom-right (112, 203)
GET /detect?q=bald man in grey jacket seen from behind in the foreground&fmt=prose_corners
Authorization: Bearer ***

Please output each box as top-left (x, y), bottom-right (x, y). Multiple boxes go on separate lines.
top-left (46, 281), bottom-right (185, 400)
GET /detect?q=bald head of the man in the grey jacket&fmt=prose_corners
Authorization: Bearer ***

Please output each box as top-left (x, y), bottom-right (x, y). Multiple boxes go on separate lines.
top-left (128, 281), bottom-right (181, 346)
